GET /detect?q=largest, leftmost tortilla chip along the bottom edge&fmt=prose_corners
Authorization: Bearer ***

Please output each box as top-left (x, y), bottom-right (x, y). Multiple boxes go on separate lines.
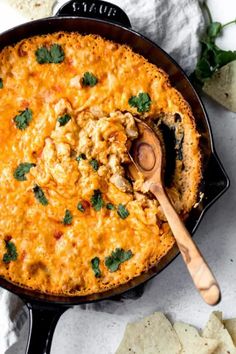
top-left (116, 312), bottom-right (181, 354)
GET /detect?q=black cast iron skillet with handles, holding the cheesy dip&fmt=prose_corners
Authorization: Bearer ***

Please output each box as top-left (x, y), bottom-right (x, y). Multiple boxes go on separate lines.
top-left (0, 0), bottom-right (229, 354)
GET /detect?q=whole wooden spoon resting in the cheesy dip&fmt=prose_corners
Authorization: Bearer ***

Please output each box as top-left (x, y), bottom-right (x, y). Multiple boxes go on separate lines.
top-left (129, 119), bottom-right (221, 305)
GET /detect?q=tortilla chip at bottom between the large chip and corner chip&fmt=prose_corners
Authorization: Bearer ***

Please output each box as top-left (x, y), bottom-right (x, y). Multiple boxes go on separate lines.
top-left (174, 322), bottom-right (219, 354)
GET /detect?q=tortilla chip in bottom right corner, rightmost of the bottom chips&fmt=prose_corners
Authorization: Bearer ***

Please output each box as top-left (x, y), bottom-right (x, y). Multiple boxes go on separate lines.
top-left (202, 312), bottom-right (236, 354)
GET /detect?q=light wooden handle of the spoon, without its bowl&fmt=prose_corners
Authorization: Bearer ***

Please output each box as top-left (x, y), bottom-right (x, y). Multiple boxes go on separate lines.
top-left (150, 184), bottom-right (221, 305)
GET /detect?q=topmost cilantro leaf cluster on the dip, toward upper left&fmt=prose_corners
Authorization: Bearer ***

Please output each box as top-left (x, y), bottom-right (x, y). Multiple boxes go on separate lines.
top-left (35, 44), bottom-right (65, 64)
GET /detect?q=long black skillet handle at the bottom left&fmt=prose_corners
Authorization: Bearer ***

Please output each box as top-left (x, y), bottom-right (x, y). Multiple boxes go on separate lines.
top-left (25, 303), bottom-right (68, 354)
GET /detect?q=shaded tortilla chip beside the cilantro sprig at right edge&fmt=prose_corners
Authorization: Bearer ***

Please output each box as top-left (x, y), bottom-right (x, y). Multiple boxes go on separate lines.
top-left (203, 60), bottom-right (236, 112)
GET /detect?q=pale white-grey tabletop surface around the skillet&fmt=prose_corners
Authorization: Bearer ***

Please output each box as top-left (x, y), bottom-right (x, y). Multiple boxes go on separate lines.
top-left (0, 0), bottom-right (236, 354)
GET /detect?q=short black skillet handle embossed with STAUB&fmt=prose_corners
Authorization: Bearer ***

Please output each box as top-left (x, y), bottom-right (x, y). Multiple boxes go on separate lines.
top-left (56, 0), bottom-right (131, 28)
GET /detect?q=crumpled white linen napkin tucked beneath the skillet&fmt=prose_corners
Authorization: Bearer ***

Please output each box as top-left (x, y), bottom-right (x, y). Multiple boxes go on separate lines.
top-left (0, 0), bottom-right (204, 354)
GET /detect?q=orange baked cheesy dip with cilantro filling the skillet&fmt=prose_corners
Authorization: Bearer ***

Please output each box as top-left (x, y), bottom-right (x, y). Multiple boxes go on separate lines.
top-left (0, 32), bottom-right (201, 296)
